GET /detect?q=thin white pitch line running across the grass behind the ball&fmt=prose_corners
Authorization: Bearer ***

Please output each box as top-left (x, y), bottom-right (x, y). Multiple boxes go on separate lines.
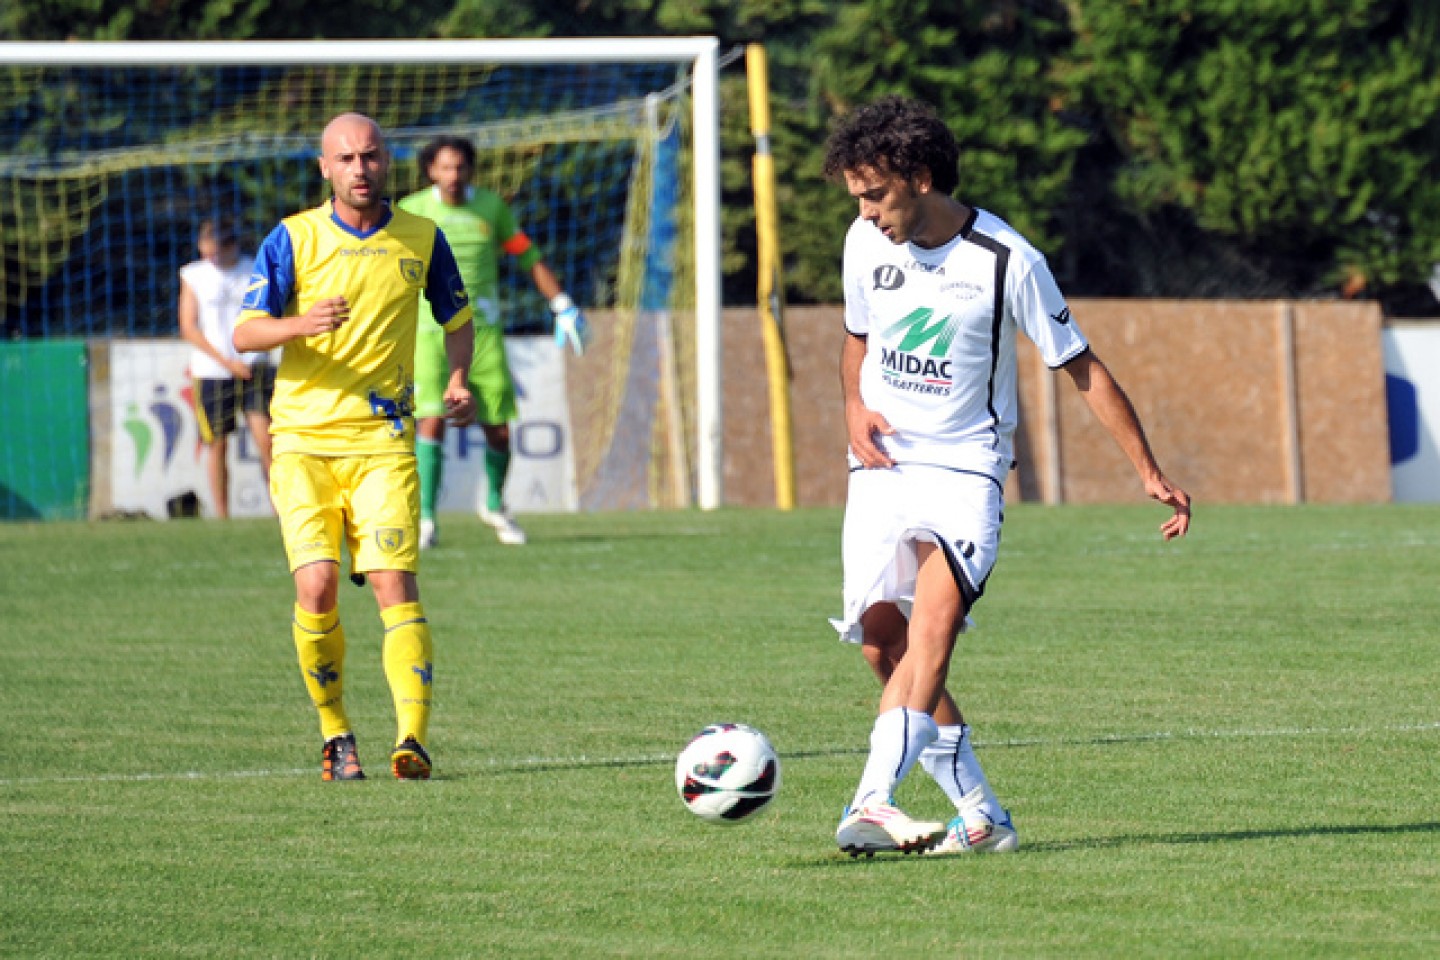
top-left (0, 721), bottom-right (1440, 787)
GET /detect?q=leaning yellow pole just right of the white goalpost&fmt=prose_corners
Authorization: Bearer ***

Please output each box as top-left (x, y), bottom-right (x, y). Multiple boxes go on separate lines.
top-left (744, 43), bottom-right (795, 510)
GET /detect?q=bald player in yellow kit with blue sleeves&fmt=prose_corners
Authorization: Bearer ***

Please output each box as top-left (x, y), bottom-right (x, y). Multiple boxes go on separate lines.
top-left (233, 114), bottom-right (475, 780)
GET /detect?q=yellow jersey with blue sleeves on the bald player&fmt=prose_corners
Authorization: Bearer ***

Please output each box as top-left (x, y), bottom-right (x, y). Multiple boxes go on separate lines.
top-left (238, 201), bottom-right (471, 456)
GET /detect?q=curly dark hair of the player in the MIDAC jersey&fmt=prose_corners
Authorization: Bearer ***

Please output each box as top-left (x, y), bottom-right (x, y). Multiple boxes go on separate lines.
top-left (825, 95), bottom-right (960, 194)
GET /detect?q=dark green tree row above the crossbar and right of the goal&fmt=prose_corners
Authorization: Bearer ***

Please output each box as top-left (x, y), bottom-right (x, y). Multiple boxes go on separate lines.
top-left (11, 0), bottom-right (1440, 309)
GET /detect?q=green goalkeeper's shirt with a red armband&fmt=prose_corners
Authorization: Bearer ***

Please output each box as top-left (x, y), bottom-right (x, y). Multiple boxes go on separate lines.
top-left (399, 187), bottom-right (540, 328)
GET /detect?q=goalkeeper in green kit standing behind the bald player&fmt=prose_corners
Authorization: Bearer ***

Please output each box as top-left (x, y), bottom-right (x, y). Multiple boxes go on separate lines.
top-left (399, 137), bottom-right (589, 548)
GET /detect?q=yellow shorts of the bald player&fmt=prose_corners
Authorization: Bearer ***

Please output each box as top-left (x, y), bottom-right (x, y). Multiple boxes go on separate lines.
top-left (271, 453), bottom-right (420, 573)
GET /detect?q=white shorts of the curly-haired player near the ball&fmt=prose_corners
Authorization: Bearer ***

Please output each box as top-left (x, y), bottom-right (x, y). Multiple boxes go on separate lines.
top-left (831, 463), bottom-right (1005, 643)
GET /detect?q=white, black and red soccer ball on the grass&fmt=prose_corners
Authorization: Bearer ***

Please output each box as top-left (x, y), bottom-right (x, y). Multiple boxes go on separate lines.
top-left (675, 724), bottom-right (780, 823)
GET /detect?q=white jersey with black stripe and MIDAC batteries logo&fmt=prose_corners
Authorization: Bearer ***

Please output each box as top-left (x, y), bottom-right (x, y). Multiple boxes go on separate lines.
top-left (844, 210), bottom-right (1089, 484)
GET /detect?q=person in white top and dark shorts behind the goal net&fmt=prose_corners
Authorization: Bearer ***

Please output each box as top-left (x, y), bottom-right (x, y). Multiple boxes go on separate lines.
top-left (177, 220), bottom-right (278, 518)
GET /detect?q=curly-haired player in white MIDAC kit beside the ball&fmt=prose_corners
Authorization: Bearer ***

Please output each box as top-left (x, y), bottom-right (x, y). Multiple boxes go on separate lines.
top-left (825, 96), bottom-right (1189, 855)
